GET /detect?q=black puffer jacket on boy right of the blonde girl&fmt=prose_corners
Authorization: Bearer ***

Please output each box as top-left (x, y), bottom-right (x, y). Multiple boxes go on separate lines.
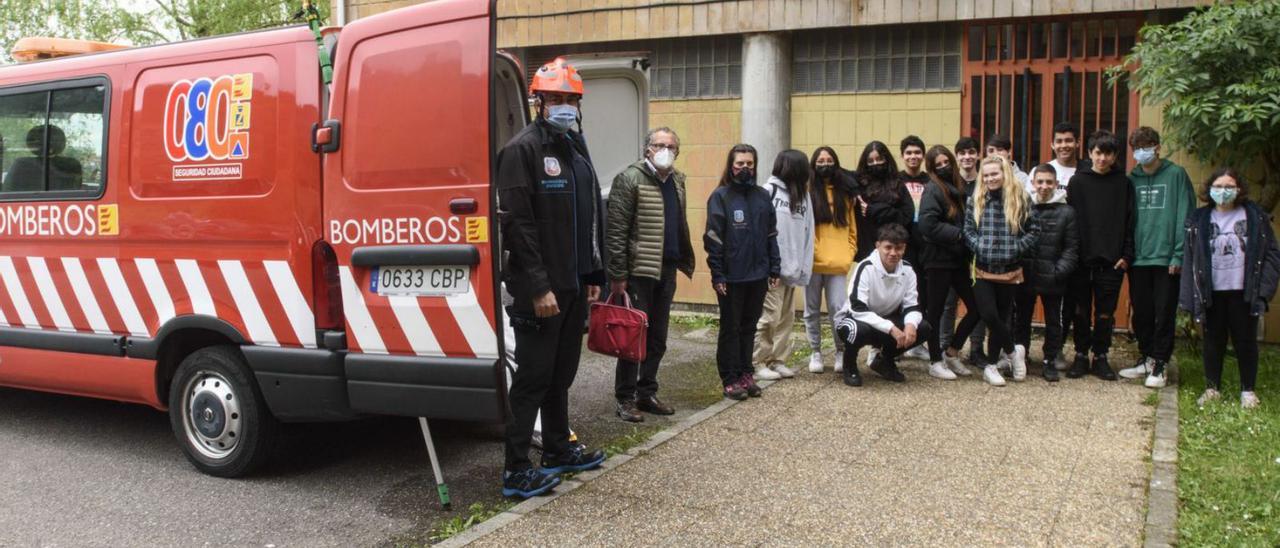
top-left (1023, 192), bottom-right (1080, 294)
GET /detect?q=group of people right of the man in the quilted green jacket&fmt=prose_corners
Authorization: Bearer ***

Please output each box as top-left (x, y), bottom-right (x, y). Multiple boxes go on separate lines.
top-left (703, 123), bottom-right (1280, 407)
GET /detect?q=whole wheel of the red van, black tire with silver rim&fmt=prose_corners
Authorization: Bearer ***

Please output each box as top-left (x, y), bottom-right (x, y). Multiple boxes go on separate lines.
top-left (169, 346), bottom-right (279, 478)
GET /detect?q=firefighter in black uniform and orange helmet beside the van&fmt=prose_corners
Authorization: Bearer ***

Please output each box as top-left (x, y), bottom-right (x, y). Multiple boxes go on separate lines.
top-left (497, 59), bottom-right (604, 498)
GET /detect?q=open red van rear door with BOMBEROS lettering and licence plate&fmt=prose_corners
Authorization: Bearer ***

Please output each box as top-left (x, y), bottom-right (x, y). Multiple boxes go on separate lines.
top-left (324, 0), bottom-right (504, 421)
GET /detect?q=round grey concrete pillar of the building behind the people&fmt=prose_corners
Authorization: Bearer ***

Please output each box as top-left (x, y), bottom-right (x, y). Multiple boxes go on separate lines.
top-left (742, 32), bottom-right (791, 179)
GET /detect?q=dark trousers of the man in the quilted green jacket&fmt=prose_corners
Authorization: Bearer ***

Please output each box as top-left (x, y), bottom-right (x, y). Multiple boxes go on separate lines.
top-left (613, 264), bottom-right (676, 402)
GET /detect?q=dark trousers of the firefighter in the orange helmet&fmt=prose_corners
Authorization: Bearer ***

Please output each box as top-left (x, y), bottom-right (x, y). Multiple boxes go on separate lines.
top-left (506, 286), bottom-right (586, 470)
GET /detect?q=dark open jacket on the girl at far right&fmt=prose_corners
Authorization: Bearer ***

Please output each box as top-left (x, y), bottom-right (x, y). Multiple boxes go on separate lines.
top-left (1178, 201), bottom-right (1280, 321)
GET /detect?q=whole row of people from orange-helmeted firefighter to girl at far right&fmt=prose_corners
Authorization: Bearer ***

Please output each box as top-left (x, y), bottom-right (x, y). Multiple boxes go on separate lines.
top-left (494, 59), bottom-right (1280, 498)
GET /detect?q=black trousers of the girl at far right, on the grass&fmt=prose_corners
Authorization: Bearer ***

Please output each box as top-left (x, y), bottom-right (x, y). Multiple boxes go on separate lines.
top-left (1204, 291), bottom-right (1258, 392)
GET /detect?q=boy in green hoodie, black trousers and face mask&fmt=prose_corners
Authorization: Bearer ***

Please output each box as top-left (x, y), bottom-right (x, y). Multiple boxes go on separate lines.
top-left (1120, 125), bottom-right (1197, 388)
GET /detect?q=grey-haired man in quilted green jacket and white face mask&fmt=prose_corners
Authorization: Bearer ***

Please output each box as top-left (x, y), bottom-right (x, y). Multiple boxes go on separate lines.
top-left (604, 127), bottom-right (694, 423)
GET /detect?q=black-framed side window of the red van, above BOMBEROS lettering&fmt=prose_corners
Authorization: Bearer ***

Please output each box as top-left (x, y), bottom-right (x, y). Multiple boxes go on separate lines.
top-left (0, 82), bottom-right (106, 200)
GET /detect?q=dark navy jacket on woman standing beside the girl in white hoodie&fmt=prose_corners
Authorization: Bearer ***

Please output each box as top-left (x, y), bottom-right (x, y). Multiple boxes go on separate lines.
top-left (703, 184), bottom-right (782, 283)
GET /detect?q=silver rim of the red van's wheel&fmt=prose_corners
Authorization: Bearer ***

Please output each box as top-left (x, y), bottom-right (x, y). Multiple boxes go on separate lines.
top-left (182, 371), bottom-right (243, 460)
